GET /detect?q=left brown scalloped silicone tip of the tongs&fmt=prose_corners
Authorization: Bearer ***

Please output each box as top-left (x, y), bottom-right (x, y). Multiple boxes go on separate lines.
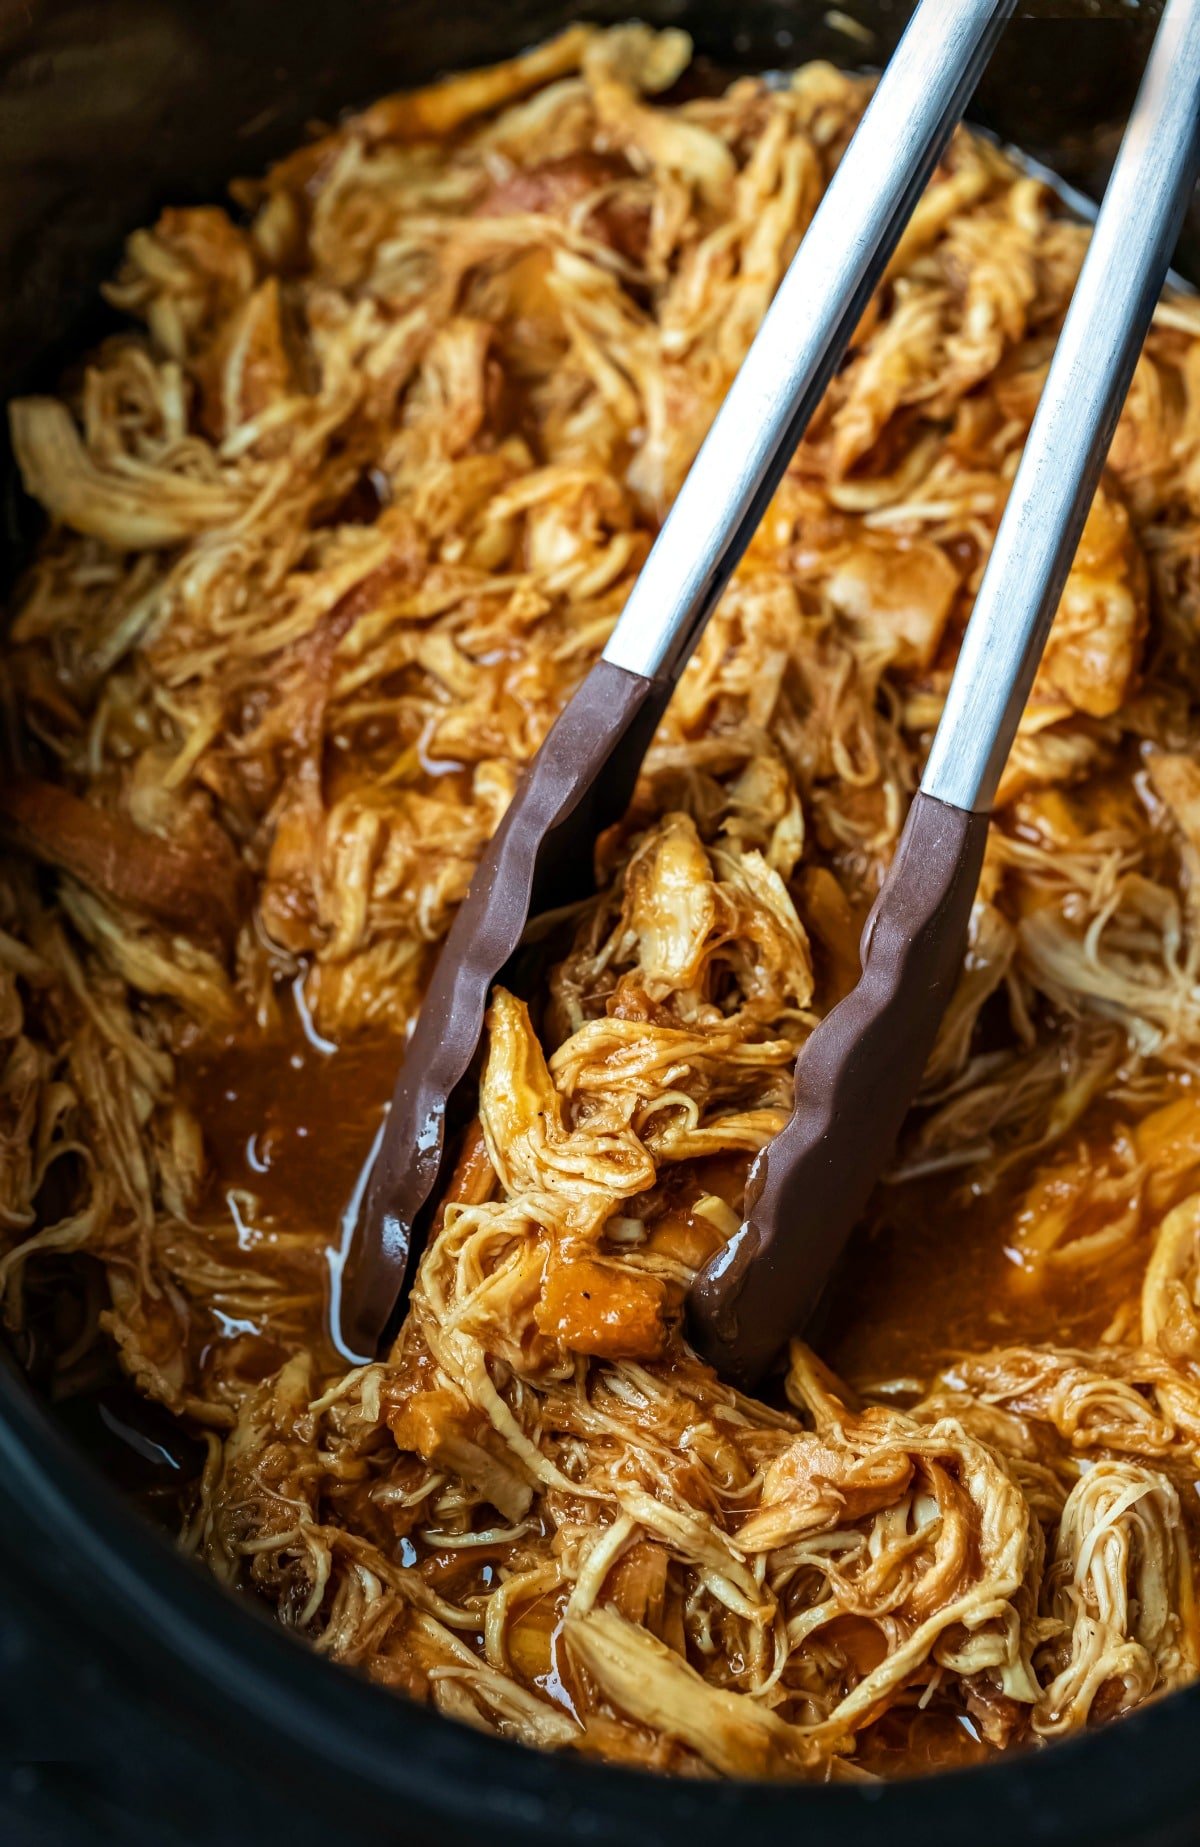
top-left (334, 659), bottom-right (668, 1358)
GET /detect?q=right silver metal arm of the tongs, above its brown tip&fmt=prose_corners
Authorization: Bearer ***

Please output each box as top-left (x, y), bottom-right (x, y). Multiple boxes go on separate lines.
top-left (921, 0), bottom-right (1200, 813)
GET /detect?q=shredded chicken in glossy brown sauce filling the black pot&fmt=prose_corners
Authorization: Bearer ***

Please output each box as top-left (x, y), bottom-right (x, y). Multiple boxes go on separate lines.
top-left (0, 26), bottom-right (1200, 1777)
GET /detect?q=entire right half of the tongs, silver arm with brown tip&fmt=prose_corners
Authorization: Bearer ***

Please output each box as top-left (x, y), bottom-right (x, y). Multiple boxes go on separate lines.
top-left (689, 0), bottom-right (1200, 1385)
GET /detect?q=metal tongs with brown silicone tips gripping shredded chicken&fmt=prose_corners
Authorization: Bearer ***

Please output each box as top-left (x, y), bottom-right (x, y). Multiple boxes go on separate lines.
top-left (334, 0), bottom-right (1200, 1385)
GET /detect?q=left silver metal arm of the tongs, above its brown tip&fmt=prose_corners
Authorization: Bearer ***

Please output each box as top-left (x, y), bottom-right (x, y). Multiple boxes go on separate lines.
top-left (604, 0), bottom-right (1015, 678)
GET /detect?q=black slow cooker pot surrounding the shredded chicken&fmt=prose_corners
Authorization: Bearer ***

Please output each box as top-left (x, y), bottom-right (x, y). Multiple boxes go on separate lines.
top-left (0, 0), bottom-right (1200, 1847)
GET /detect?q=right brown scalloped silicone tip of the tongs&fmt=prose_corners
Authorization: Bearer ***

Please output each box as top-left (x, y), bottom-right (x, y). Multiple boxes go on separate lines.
top-left (689, 794), bottom-right (988, 1387)
